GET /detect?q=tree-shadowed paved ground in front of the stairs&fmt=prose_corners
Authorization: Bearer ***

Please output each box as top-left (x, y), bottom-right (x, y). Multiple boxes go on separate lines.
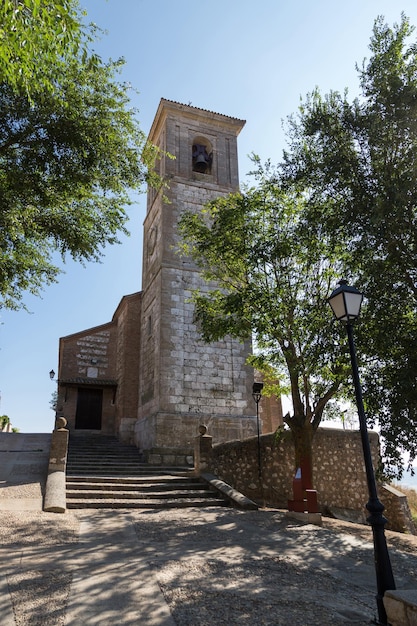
top-left (0, 508), bottom-right (417, 626)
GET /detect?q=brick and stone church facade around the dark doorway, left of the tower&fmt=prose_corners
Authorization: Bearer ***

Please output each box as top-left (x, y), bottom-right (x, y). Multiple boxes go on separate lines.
top-left (57, 292), bottom-right (141, 442)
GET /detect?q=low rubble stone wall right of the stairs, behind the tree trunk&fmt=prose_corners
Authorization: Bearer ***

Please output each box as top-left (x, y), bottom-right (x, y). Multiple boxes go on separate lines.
top-left (204, 428), bottom-right (413, 532)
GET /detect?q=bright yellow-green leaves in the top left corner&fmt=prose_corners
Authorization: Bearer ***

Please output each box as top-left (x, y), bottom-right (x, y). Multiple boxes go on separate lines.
top-left (0, 0), bottom-right (86, 97)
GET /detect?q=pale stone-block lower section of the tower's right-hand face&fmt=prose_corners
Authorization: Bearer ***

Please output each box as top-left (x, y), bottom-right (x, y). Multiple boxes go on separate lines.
top-left (161, 270), bottom-right (250, 416)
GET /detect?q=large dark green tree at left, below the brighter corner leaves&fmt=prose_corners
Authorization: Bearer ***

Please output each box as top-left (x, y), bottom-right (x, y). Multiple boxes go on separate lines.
top-left (0, 2), bottom-right (159, 309)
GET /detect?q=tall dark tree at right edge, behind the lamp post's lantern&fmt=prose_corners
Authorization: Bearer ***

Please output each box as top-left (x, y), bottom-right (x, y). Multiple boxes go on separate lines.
top-left (280, 15), bottom-right (417, 476)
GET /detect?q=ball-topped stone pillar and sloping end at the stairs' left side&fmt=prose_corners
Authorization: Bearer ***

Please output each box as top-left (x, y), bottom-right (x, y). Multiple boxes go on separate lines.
top-left (43, 417), bottom-right (69, 513)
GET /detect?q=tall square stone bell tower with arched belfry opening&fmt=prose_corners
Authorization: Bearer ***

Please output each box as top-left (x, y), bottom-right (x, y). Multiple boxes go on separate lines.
top-left (135, 99), bottom-right (256, 450)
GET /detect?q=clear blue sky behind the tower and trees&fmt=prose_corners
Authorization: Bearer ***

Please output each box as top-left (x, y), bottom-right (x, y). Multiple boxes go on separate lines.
top-left (0, 0), bottom-right (417, 432)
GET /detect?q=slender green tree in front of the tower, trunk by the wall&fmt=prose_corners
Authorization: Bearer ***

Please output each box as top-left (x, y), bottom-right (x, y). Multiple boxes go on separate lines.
top-left (179, 160), bottom-right (348, 488)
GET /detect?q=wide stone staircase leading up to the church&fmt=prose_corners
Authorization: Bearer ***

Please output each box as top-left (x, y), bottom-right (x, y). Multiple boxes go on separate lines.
top-left (66, 434), bottom-right (228, 509)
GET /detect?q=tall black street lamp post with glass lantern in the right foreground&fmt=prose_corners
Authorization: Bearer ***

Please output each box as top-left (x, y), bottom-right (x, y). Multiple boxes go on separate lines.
top-left (328, 280), bottom-right (395, 624)
